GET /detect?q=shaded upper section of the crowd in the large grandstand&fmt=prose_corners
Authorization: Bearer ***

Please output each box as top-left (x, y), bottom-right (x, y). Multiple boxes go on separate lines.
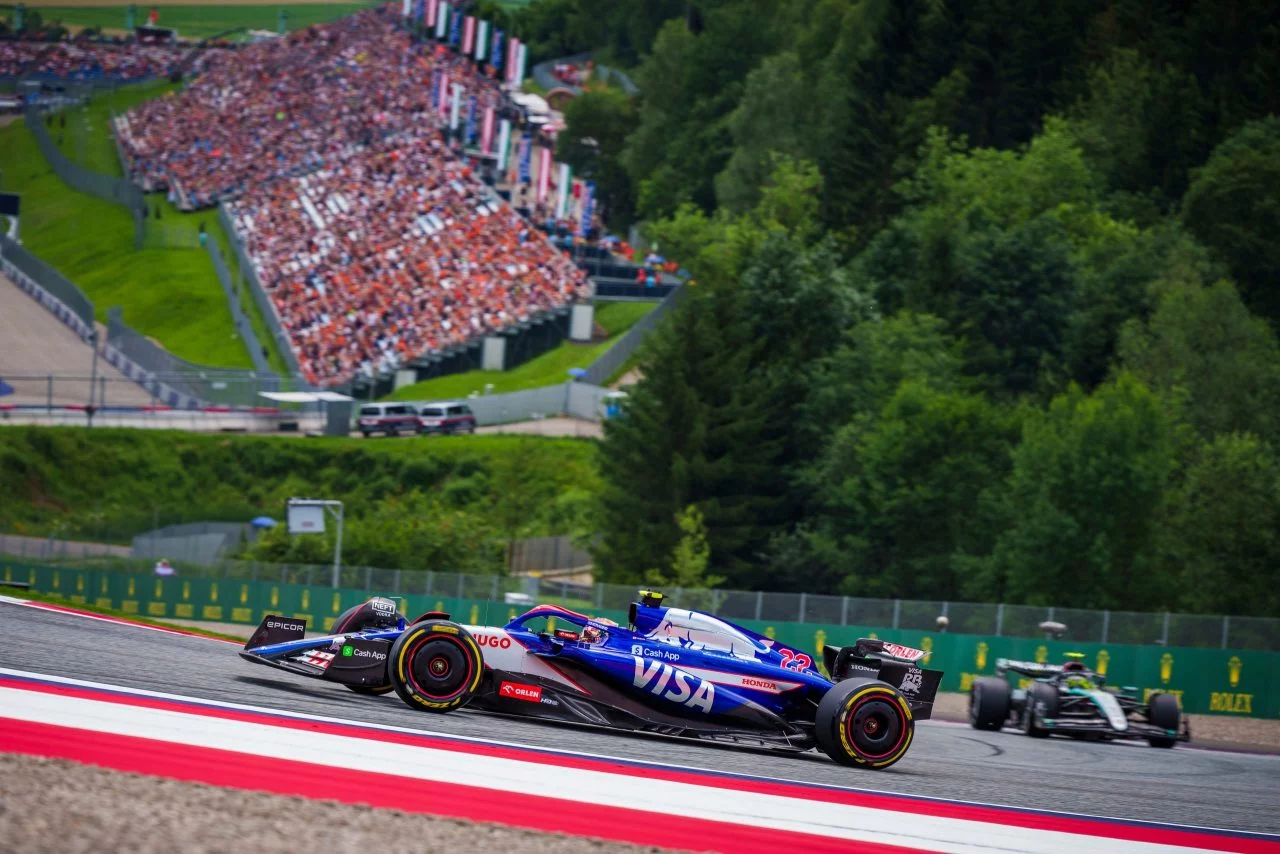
top-left (119, 8), bottom-right (499, 207)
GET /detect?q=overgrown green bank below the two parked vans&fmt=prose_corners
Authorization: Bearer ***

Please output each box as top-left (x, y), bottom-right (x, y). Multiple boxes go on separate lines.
top-left (0, 426), bottom-right (598, 545)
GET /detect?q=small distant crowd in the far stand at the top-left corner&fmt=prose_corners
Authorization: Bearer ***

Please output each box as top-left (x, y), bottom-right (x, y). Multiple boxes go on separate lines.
top-left (0, 41), bottom-right (186, 82)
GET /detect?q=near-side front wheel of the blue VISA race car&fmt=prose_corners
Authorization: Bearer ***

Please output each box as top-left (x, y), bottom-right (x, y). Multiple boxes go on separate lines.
top-left (388, 620), bottom-right (484, 712)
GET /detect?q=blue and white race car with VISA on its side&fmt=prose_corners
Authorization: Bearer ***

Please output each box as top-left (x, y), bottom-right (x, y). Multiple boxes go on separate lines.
top-left (241, 592), bottom-right (942, 768)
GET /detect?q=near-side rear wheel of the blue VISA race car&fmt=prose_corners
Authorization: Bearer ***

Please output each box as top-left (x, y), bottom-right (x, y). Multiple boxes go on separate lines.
top-left (814, 679), bottom-right (915, 769)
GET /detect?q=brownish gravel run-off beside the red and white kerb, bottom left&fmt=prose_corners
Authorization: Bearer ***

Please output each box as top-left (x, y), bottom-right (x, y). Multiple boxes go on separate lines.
top-left (0, 754), bottom-right (660, 854)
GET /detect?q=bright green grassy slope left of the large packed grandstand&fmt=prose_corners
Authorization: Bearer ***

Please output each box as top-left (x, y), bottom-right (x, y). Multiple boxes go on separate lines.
top-left (0, 83), bottom-right (284, 369)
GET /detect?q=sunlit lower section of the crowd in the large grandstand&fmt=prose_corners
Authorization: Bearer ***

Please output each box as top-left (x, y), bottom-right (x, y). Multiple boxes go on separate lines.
top-left (230, 125), bottom-right (588, 385)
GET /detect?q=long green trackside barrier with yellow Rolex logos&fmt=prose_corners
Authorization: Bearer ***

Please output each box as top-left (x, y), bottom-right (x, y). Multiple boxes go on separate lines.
top-left (0, 558), bottom-right (1280, 718)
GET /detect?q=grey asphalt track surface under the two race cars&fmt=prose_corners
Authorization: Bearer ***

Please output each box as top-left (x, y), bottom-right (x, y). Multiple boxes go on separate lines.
top-left (0, 603), bottom-right (1280, 834)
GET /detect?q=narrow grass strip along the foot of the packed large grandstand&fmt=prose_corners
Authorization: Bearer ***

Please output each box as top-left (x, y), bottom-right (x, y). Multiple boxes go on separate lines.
top-left (387, 302), bottom-right (657, 401)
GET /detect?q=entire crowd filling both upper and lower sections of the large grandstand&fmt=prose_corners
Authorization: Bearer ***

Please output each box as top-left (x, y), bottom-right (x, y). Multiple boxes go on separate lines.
top-left (108, 6), bottom-right (588, 387)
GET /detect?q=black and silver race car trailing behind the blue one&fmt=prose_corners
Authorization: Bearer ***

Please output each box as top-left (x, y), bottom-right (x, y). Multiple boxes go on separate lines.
top-left (969, 653), bottom-right (1190, 748)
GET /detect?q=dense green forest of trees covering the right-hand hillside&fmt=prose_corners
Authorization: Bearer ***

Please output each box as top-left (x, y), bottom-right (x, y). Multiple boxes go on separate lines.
top-left (537, 0), bottom-right (1280, 616)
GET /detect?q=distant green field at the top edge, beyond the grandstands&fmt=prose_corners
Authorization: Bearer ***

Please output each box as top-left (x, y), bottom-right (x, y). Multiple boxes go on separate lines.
top-left (27, 3), bottom-right (376, 38)
